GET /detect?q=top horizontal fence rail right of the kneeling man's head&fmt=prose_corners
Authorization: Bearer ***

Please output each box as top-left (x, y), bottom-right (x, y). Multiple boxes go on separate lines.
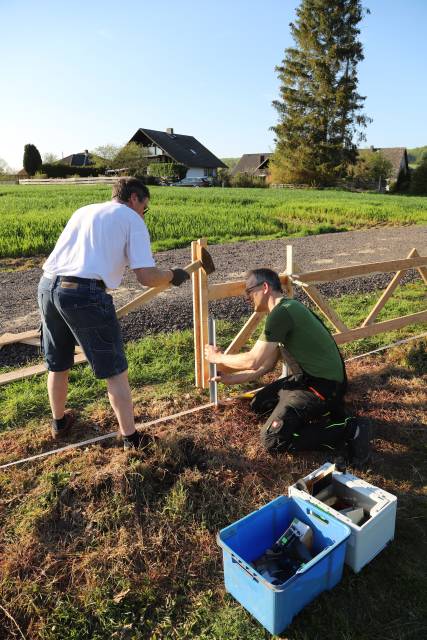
top-left (297, 257), bottom-right (427, 282)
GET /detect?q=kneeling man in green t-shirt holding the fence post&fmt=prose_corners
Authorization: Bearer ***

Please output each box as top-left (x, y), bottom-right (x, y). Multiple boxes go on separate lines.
top-left (205, 269), bottom-right (369, 466)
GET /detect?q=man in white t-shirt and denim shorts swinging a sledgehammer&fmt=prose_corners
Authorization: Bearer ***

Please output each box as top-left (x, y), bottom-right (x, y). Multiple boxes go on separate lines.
top-left (38, 178), bottom-right (189, 449)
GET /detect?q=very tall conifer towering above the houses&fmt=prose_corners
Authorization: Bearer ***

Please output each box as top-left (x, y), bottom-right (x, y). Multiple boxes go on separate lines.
top-left (270, 0), bottom-right (370, 184)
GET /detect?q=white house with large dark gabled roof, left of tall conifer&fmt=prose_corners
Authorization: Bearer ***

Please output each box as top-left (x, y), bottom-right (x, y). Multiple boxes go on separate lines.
top-left (128, 128), bottom-right (226, 178)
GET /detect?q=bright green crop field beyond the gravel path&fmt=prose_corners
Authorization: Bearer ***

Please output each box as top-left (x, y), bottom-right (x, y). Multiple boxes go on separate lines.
top-left (0, 185), bottom-right (427, 258)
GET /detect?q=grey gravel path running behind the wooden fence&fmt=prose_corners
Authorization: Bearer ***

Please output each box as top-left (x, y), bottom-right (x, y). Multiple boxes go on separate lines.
top-left (0, 226), bottom-right (427, 366)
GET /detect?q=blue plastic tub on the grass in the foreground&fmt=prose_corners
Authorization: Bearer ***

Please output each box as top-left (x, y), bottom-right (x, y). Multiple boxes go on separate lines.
top-left (217, 496), bottom-right (350, 634)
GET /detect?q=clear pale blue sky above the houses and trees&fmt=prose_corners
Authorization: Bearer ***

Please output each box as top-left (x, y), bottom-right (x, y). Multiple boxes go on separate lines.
top-left (0, 0), bottom-right (427, 169)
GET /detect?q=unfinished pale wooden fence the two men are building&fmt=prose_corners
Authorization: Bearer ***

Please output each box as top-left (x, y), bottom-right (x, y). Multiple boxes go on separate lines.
top-left (0, 239), bottom-right (427, 388)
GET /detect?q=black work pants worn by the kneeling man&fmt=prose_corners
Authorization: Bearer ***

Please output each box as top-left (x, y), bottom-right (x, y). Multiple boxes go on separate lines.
top-left (251, 374), bottom-right (355, 453)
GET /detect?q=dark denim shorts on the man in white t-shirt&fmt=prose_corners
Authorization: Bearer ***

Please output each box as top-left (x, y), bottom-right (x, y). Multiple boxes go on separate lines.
top-left (38, 276), bottom-right (128, 378)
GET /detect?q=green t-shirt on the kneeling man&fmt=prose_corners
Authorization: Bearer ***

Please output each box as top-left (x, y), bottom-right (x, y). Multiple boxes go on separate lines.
top-left (260, 298), bottom-right (344, 382)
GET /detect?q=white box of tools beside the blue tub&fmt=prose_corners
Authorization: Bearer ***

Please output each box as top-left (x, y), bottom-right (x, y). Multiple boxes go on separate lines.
top-left (288, 462), bottom-right (397, 573)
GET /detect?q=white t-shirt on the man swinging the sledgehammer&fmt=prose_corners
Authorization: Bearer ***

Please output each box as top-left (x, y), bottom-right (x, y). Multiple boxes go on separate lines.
top-left (43, 200), bottom-right (155, 289)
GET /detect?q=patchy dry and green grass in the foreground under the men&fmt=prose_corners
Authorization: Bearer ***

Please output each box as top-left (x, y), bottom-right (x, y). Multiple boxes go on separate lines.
top-left (0, 283), bottom-right (427, 640)
